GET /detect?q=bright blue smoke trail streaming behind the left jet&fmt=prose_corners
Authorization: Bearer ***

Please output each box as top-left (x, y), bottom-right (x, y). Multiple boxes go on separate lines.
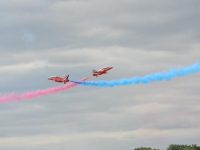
top-left (71, 61), bottom-right (200, 87)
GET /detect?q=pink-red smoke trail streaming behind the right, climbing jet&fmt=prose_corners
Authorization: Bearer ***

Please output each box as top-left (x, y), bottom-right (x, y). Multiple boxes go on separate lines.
top-left (0, 76), bottom-right (92, 102)
